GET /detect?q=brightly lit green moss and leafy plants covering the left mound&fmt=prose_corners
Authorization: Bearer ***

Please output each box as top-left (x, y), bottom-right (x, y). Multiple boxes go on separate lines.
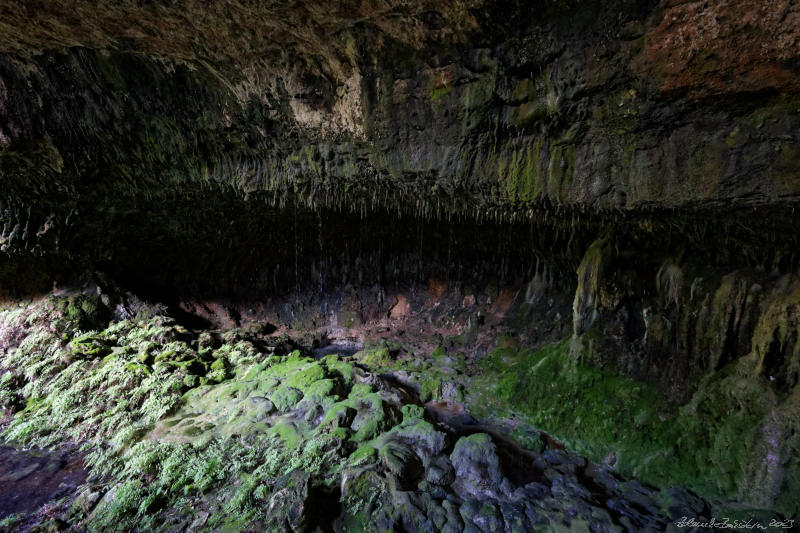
top-left (0, 304), bottom-right (444, 531)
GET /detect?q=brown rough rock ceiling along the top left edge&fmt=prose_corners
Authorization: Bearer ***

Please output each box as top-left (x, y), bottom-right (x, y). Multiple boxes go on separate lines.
top-left (0, 0), bottom-right (482, 85)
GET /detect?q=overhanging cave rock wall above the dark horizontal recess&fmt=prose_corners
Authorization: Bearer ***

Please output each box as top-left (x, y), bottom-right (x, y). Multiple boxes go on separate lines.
top-left (0, 1), bottom-right (800, 222)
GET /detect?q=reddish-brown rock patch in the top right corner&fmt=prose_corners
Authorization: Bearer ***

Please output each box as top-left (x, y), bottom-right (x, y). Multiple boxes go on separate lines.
top-left (632, 0), bottom-right (800, 98)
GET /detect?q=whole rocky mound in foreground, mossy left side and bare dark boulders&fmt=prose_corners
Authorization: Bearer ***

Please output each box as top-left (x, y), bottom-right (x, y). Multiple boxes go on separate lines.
top-left (0, 284), bottom-right (788, 531)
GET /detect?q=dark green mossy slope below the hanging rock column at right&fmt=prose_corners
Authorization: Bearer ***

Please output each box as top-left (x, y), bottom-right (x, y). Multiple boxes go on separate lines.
top-left (467, 342), bottom-right (797, 512)
